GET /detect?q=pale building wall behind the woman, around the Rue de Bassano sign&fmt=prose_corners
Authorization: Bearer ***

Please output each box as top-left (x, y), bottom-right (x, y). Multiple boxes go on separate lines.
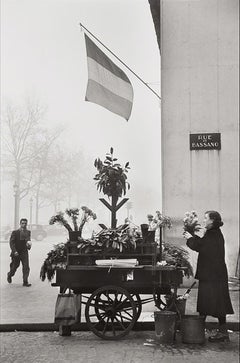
top-left (160, 0), bottom-right (239, 275)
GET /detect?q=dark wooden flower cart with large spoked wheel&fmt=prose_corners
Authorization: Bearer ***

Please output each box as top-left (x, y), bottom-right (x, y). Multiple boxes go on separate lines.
top-left (52, 238), bottom-right (184, 340)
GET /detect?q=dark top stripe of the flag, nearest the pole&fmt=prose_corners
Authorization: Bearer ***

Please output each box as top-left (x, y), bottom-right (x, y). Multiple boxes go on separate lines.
top-left (85, 34), bottom-right (131, 84)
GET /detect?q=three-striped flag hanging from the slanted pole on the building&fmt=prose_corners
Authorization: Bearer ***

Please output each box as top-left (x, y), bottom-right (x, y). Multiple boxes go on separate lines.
top-left (85, 34), bottom-right (133, 120)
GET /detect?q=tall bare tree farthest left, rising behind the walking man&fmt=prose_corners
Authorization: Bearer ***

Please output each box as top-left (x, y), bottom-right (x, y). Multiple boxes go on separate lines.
top-left (2, 100), bottom-right (62, 224)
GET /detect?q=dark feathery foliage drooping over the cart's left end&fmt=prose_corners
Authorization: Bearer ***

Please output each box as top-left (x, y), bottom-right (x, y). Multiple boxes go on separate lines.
top-left (40, 243), bottom-right (67, 281)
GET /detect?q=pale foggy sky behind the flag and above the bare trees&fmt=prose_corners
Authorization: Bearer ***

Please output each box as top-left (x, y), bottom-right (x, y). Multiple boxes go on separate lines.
top-left (1, 0), bottom-right (161, 229)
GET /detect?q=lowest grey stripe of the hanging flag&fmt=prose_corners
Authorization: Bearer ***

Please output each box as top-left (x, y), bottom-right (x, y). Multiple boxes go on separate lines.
top-left (85, 79), bottom-right (132, 120)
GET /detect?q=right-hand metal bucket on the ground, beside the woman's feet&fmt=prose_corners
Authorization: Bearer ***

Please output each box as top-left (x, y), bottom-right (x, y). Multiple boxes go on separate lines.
top-left (181, 315), bottom-right (205, 344)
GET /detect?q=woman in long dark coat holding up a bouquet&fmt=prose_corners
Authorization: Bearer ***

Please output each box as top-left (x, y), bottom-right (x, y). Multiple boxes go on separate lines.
top-left (184, 211), bottom-right (234, 342)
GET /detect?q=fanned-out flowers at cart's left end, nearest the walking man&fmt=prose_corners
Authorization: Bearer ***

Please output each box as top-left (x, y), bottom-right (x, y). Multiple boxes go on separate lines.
top-left (49, 206), bottom-right (97, 235)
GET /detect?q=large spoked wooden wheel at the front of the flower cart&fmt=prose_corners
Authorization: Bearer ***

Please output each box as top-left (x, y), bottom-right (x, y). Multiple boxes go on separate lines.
top-left (85, 286), bottom-right (138, 340)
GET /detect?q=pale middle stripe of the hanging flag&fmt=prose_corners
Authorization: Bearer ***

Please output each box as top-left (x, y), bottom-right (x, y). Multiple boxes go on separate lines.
top-left (88, 58), bottom-right (133, 102)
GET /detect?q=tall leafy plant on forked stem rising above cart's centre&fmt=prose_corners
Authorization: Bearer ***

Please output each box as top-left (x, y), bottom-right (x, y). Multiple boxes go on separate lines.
top-left (94, 147), bottom-right (130, 228)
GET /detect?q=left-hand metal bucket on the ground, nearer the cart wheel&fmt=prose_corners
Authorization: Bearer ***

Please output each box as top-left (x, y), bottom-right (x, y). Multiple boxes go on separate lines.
top-left (154, 310), bottom-right (176, 344)
